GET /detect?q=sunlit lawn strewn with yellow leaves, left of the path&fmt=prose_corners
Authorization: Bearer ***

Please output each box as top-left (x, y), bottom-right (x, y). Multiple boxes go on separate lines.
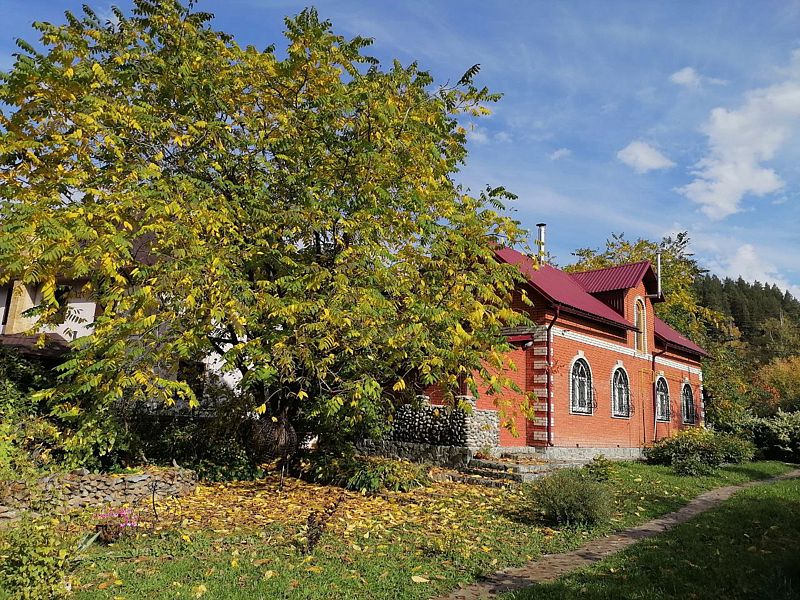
top-left (48, 462), bottom-right (797, 599)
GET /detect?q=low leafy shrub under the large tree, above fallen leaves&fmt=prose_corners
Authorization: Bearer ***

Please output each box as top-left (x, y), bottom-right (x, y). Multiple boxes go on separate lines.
top-left (305, 453), bottom-right (430, 494)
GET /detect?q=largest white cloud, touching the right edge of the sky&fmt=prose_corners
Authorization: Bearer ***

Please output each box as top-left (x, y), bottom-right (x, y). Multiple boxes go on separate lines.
top-left (679, 50), bottom-right (800, 219)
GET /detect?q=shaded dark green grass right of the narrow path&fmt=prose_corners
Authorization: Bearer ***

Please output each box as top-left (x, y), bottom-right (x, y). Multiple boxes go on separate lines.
top-left (505, 480), bottom-right (800, 600)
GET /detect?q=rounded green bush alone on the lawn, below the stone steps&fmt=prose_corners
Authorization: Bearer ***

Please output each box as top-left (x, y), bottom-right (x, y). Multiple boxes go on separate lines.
top-left (525, 468), bottom-right (613, 525)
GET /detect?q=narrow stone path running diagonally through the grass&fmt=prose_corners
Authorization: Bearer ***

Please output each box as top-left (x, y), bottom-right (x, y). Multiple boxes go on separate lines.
top-left (438, 469), bottom-right (800, 600)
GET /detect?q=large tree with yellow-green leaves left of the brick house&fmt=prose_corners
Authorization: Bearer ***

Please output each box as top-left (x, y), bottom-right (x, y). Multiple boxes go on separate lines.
top-left (0, 0), bottom-right (524, 460)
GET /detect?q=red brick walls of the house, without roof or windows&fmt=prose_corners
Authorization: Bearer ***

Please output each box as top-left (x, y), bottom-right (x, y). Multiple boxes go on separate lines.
top-left (427, 284), bottom-right (702, 447)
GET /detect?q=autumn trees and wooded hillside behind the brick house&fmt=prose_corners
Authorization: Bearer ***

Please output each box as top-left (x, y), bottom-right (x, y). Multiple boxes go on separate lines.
top-left (564, 232), bottom-right (800, 430)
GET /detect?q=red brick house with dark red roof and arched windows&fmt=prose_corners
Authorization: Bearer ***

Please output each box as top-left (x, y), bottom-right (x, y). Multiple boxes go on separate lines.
top-left (427, 232), bottom-right (706, 456)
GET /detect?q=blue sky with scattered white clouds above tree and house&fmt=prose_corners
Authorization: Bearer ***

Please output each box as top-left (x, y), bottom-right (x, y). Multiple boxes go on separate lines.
top-left (0, 0), bottom-right (800, 297)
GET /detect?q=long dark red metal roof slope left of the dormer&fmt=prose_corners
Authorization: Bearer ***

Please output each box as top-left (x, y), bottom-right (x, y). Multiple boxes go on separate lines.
top-left (495, 248), bottom-right (634, 329)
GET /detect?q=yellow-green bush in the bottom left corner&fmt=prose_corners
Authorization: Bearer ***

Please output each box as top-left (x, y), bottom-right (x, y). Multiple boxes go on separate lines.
top-left (0, 516), bottom-right (69, 600)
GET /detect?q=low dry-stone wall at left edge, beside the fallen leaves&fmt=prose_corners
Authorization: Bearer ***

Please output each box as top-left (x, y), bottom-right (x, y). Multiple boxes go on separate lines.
top-left (0, 468), bottom-right (197, 520)
